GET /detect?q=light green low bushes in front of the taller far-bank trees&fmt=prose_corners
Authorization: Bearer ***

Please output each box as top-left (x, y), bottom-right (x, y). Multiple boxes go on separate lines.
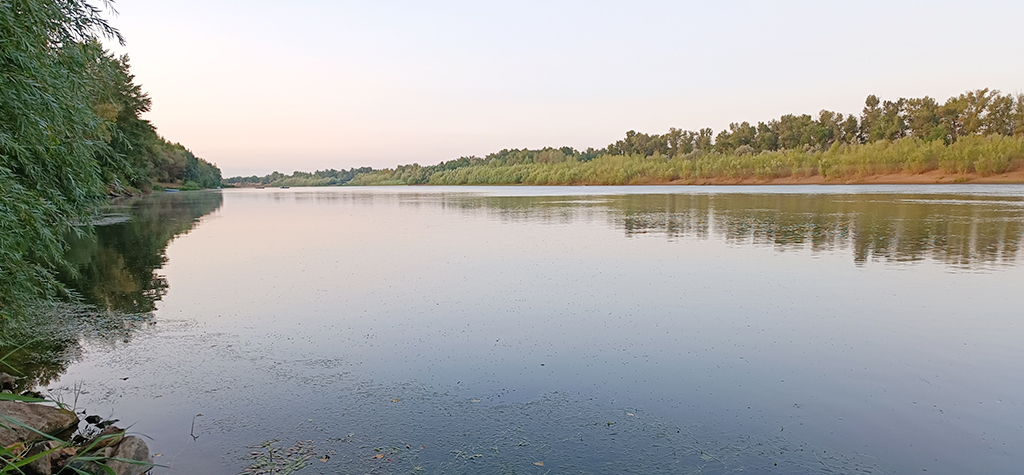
top-left (344, 135), bottom-right (1024, 185)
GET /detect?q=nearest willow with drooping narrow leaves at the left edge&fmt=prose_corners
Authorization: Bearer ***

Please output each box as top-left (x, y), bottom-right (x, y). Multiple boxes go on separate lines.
top-left (0, 0), bottom-right (122, 313)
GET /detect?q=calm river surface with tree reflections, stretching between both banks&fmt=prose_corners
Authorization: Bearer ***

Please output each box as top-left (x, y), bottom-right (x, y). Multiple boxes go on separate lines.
top-left (24, 186), bottom-right (1024, 475)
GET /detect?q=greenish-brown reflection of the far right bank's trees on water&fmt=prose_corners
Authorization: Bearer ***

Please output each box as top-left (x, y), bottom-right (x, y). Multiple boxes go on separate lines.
top-left (442, 193), bottom-right (1024, 267)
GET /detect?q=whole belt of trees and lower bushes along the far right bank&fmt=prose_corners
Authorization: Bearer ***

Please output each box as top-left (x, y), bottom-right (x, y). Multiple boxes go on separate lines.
top-left (224, 89), bottom-right (1024, 186)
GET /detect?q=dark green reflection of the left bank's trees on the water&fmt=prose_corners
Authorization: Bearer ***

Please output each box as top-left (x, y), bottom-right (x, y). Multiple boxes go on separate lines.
top-left (0, 191), bottom-right (223, 388)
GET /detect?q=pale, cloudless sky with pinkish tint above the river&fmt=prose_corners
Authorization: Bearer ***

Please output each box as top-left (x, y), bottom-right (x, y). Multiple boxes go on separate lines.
top-left (97, 0), bottom-right (1024, 177)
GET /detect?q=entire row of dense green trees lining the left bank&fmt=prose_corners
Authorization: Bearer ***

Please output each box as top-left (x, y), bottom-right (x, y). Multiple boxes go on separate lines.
top-left (0, 0), bottom-right (220, 316)
